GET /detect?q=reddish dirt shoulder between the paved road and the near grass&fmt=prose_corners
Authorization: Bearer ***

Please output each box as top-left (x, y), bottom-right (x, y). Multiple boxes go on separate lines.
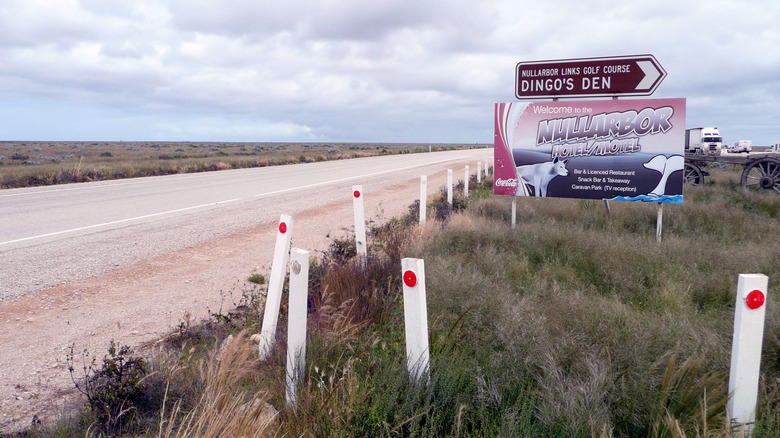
top-left (0, 172), bottom-right (454, 432)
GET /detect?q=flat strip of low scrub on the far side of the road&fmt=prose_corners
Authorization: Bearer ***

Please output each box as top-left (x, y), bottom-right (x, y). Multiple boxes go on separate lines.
top-left (0, 141), bottom-right (478, 189)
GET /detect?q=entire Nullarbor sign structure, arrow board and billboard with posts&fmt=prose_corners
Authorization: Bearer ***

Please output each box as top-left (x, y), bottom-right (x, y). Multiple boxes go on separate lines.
top-left (502, 55), bottom-right (672, 236)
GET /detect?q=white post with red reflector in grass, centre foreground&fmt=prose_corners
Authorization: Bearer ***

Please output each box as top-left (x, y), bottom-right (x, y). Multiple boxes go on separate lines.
top-left (401, 258), bottom-right (431, 383)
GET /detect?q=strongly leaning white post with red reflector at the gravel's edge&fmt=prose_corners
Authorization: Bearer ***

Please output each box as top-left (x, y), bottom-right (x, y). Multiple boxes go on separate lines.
top-left (258, 214), bottom-right (293, 359)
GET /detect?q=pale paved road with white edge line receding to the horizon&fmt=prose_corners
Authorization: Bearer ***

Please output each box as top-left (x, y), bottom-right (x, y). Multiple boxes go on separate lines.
top-left (0, 149), bottom-right (492, 302)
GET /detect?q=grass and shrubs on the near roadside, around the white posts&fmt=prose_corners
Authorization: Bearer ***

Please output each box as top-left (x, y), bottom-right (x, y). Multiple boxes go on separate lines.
top-left (6, 163), bottom-right (780, 437)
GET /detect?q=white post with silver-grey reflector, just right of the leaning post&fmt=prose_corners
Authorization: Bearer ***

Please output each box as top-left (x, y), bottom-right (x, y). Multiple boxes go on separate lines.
top-left (285, 248), bottom-right (309, 406)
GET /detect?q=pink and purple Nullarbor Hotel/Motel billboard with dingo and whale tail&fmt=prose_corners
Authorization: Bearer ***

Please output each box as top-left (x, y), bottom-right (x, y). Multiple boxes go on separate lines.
top-left (493, 98), bottom-right (685, 203)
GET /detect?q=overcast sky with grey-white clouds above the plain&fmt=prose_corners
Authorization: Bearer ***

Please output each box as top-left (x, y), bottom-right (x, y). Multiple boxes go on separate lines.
top-left (0, 0), bottom-right (780, 145)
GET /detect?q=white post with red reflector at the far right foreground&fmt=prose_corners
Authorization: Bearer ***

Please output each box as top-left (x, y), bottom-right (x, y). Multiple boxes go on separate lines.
top-left (726, 274), bottom-right (769, 433)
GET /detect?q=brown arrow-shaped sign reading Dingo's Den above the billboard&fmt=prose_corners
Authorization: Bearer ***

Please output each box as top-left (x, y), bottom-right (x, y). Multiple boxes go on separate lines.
top-left (515, 55), bottom-right (666, 99)
